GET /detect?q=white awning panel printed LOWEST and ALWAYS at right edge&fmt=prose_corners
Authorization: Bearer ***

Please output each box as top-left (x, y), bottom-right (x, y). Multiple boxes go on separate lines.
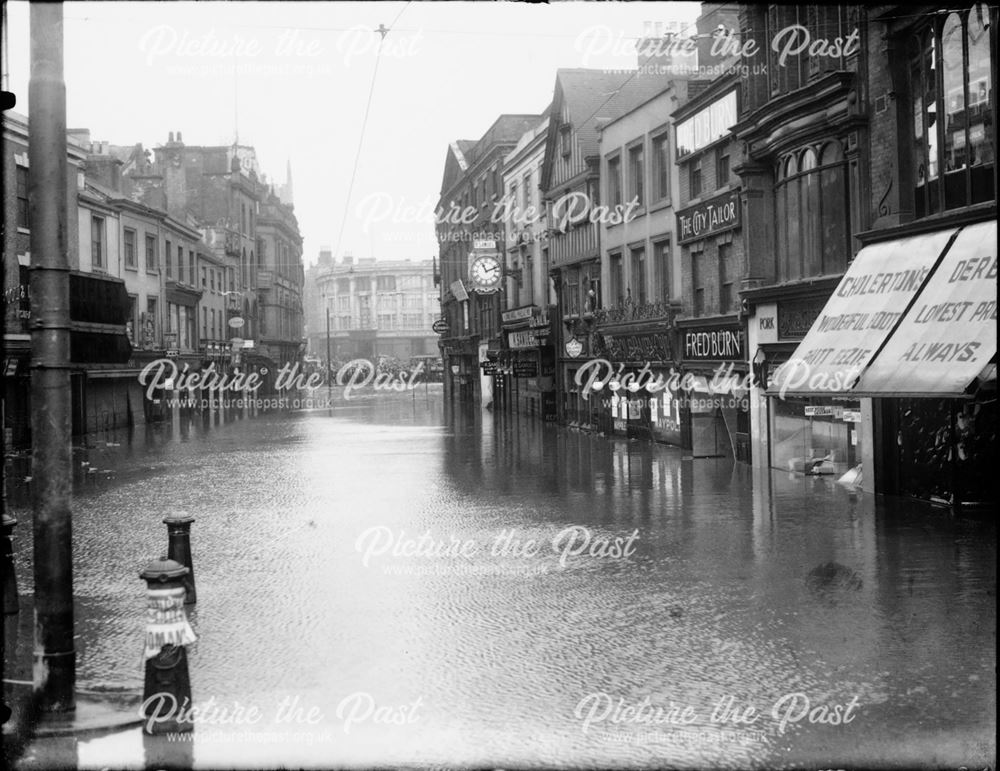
top-left (856, 221), bottom-right (997, 396)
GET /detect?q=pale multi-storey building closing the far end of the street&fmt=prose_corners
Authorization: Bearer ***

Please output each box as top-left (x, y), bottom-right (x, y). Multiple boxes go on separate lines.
top-left (310, 255), bottom-right (440, 361)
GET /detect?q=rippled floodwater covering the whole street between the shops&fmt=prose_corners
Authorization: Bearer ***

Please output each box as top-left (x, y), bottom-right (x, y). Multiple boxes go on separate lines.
top-left (8, 387), bottom-right (996, 768)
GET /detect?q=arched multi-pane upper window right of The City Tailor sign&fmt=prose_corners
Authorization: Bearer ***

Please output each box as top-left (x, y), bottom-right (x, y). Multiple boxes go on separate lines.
top-left (774, 141), bottom-right (850, 281)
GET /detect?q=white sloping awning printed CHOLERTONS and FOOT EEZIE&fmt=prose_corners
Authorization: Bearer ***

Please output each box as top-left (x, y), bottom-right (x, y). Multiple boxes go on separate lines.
top-left (767, 223), bottom-right (964, 396)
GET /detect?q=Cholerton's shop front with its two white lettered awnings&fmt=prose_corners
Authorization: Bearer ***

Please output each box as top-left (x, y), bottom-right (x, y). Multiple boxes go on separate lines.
top-left (768, 220), bottom-right (997, 507)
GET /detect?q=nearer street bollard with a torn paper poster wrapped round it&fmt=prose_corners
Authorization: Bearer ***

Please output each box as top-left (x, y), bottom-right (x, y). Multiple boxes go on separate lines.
top-left (139, 557), bottom-right (197, 734)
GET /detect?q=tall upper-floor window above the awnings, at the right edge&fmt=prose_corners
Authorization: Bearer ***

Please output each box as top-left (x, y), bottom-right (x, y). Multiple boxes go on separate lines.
top-left (908, 3), bottom-right (996, 217)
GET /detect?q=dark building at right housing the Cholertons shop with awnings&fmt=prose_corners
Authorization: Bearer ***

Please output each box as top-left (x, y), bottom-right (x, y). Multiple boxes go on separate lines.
top-left (736, 4), bottom-right (997, 507)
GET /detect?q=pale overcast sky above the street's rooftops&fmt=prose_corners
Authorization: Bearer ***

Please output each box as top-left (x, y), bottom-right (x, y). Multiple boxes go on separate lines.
top-left (7, 2), bottom-right (699, 265)
